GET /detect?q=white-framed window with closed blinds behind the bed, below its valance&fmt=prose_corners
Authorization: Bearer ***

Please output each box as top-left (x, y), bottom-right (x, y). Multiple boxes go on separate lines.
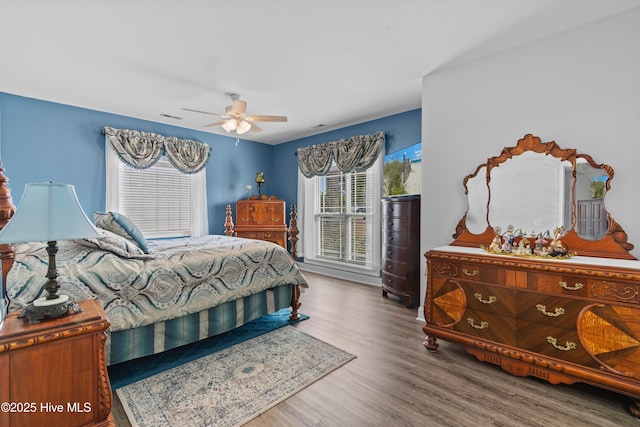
top-left (106, 143), bottom-right (208, 238)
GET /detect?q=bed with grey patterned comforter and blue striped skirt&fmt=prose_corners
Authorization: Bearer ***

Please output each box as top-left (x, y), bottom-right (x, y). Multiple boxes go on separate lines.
top-left (6, 206), bottom-right (308, 365)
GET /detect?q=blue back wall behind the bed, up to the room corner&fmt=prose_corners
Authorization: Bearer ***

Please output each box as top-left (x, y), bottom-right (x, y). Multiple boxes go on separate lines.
top-left (0, 92), bottom-right (273, 234)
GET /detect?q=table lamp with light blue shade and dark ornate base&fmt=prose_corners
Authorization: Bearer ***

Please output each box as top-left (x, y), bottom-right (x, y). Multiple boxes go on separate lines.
top-left (0, 182), bottom-right (102, 323)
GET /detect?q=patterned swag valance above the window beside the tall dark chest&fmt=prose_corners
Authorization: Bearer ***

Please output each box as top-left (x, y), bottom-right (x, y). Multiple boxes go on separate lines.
top-left (296, 131), bottom-right (385, 178)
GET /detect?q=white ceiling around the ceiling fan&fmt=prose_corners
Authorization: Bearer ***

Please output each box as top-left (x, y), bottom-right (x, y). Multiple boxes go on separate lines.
top-left (0, 0), bottom-right (640, 144)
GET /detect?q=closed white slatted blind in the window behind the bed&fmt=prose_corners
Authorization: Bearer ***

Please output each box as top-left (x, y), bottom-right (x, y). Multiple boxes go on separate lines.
top-left (118, 157), bottom-right (192, 238)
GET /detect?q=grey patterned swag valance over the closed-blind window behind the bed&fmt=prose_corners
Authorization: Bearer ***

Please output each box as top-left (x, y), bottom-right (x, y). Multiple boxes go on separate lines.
top-left (102, 126), bottom-right (211, 174)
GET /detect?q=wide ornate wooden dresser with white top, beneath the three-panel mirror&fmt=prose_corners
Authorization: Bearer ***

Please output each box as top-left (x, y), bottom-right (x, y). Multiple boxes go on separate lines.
top-left (423, 246), bottom-right (640, 414)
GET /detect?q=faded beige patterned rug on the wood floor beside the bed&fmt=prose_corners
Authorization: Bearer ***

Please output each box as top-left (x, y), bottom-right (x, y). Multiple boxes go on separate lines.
top-left (116, 326), bottom-right (355, 427)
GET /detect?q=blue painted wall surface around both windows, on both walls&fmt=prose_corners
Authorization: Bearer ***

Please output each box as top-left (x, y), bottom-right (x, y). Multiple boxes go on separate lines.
top-left (0, 92), bottom-right (421, 234)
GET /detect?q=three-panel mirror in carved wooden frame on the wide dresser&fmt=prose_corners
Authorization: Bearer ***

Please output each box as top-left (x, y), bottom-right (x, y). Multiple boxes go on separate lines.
top-left (452, 134), bottom-right (635, 259)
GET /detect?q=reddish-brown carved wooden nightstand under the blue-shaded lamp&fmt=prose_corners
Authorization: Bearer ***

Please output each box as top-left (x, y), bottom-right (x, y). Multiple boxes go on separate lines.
top-left (0, 300), bottom-right (115, 427)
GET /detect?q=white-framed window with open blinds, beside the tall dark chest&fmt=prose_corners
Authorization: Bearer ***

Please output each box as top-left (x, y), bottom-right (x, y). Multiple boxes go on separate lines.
top-left (300, 156), bottom-right (382, 275)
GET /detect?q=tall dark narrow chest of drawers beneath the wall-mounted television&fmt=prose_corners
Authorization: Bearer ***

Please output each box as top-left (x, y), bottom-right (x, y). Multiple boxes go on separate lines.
top-left (382, 195), bottom-right (420, 308)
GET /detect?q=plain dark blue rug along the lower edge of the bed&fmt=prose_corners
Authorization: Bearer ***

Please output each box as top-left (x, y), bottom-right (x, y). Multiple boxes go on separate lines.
top-left (108, 308), bottom-right (309, 390)
